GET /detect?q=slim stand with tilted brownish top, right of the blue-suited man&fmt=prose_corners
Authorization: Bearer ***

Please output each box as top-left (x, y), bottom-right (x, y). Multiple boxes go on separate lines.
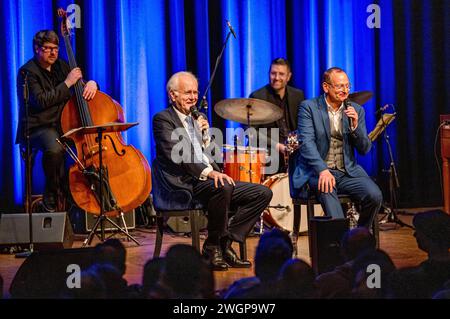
top-left (369, 113), bottom-right (413, 228)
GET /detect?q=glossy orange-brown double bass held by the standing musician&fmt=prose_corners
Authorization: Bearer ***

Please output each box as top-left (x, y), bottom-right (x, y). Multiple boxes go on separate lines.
top-left (58, 9), bottom-right (151, 216)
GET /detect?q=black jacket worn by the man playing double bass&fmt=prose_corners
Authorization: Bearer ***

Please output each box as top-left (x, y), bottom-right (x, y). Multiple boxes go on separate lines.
top-left (16, 58), bottom-right (71, 143)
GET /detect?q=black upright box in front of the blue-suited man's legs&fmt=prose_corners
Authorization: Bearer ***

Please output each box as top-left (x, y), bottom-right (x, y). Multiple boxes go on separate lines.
top-left (309, 217), bottom-right (349, 275)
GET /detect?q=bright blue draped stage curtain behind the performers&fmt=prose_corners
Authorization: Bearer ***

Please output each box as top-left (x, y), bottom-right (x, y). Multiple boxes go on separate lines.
top-left (0, 0), bottom-right (450, 209)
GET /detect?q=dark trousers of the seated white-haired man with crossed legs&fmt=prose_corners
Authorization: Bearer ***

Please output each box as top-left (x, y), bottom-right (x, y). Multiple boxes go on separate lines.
top-left (194, 179), bottom-right (272, 245)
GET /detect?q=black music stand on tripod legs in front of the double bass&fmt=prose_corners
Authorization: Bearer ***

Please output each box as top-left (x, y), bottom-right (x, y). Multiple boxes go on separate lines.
top-left (62, 122), bottom-right (140, 247)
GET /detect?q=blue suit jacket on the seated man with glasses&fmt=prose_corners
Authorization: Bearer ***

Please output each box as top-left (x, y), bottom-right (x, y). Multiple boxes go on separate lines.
top-left (292, 95), bottom-right (372, 195)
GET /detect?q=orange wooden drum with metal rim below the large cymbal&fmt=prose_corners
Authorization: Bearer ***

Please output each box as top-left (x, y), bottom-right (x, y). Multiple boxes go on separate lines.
top-left (224, 146), bottom-right (266, 184)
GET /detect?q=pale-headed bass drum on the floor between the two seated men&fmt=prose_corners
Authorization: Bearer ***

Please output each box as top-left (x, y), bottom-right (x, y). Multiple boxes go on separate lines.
top-left (263, 173), bottom-right (324, 233)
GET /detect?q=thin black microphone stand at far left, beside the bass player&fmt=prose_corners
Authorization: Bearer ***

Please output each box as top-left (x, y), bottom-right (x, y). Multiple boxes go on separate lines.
top-left (15, 71), bottom-right (34, 258)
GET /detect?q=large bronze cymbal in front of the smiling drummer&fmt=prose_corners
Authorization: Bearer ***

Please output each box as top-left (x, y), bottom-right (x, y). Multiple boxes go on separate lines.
top-left (214, 98), bottom-right (283, 125)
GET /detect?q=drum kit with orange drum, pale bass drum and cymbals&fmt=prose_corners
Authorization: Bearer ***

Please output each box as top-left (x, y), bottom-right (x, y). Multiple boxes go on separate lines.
top-left (214, 91), bottom-right (372, 232)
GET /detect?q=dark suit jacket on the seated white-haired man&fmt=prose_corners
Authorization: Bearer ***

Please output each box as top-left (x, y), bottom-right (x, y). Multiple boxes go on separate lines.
top-left (153, 106), bottom-right (220, 194)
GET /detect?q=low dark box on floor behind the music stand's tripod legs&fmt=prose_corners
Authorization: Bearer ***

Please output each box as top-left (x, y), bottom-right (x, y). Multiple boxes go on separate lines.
top-left (70, 208), bottom-right (136, 234)
